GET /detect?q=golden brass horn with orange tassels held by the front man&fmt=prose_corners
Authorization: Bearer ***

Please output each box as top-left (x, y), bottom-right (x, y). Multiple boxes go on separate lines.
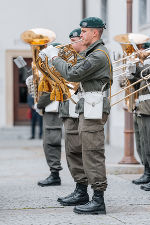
top-left (36, 41), bottom-right (79, 101)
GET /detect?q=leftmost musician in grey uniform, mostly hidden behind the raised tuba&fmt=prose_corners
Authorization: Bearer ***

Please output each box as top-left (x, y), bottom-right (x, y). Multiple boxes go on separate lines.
top-left (26, 43), bottom-right (62, 187)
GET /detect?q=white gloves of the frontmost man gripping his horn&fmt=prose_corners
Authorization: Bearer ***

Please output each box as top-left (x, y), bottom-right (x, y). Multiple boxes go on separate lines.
top-left (39, 45), bottom-right (59, 61)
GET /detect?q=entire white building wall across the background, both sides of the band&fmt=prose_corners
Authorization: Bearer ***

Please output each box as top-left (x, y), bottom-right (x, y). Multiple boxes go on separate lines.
top-left (0, 0), bottom-right (150, 151)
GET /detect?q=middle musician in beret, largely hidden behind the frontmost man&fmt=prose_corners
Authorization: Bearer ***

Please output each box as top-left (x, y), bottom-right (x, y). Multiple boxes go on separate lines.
top-left (58, 28), bottom-right (89, 205)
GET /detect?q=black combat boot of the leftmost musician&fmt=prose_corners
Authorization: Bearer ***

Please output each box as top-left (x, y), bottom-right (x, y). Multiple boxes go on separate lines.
top-left (38, 172), bottom-right (61, 187)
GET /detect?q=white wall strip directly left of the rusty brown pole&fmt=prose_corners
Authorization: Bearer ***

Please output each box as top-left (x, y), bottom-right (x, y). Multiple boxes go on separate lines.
top-left (108, 0), bottom-right (126, 147)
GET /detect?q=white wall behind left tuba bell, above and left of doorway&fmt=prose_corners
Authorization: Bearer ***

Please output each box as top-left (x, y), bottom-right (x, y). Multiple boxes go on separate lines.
top-left (0, 0), bottom-right (82, 127)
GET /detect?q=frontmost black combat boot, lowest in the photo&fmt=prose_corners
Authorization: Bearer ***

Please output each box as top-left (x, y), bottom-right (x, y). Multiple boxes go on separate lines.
top-left (73, 190), bottom-right (106, 214)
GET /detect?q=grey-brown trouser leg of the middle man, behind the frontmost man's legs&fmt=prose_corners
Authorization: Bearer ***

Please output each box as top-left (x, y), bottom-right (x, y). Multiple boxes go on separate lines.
top-left (64, 118), bottom-right (88, 185)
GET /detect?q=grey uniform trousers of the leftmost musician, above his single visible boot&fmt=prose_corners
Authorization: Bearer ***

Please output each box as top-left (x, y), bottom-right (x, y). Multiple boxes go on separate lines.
top-left (43, 112), bottom-right (62, 172)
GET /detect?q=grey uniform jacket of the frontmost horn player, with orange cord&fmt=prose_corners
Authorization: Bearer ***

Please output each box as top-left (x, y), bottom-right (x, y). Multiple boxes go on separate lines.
top-left (52, 39), bottom-right (112, 114)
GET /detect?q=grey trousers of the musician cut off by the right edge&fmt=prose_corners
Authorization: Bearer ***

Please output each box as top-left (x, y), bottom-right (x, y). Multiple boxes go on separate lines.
top-left (141, 115), bottom-right (150, 167)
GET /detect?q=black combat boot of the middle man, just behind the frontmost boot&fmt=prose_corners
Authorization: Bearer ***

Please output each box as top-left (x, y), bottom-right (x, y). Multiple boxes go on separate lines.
top-left (58, 183), bottom-right (89, 206)
